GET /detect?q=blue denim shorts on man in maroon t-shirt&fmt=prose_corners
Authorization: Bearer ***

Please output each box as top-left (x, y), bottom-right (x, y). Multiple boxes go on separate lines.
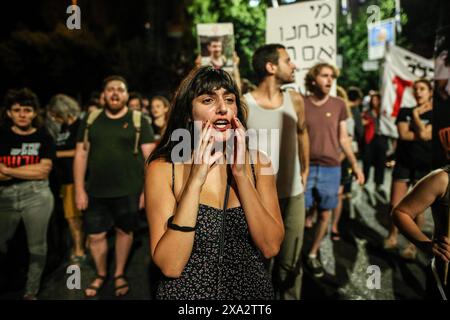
top-left (305, 165), bottom-right (341, 211)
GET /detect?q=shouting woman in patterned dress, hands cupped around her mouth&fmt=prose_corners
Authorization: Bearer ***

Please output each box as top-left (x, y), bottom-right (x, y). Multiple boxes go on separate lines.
top-left (145, 66), bottom-right (284, 300)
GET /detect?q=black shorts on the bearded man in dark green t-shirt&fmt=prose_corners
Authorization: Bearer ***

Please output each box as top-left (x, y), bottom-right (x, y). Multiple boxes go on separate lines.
top-left (83, 194), bottom-right (140, 234)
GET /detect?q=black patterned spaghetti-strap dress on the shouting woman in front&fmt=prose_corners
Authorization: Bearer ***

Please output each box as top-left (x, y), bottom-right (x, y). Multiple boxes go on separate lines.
top-left (156, 163), bottom-right (274, 300)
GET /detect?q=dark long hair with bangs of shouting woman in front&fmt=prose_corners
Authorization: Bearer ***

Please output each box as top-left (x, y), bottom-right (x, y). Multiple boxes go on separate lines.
top-left (147, 66), bottom-right (247, 164)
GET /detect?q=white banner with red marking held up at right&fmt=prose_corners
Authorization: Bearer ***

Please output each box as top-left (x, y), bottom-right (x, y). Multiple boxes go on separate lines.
top-left (380, 46), bottom-right (434, 138)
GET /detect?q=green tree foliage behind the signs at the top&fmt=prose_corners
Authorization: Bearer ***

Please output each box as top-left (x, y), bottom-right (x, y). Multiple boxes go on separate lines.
top-left (187, 0), bottom-right (408, 91)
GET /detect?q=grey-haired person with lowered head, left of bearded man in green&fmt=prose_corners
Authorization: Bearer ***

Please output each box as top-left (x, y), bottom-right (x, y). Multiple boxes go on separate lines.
top-left (47, 94), bottom-right (86, 264)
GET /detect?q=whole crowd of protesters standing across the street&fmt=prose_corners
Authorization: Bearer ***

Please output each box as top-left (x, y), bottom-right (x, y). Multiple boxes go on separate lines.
top-left (0, 41), bottom-right (450, 300)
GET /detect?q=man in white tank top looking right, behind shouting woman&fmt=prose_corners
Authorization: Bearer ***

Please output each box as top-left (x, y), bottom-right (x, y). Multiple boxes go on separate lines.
top-left (244, 44), bottom-right (309, 300)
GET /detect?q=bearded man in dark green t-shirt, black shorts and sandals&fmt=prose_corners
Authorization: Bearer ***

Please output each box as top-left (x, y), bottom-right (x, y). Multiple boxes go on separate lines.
top-left (74, 76), bottom-right (154, 297)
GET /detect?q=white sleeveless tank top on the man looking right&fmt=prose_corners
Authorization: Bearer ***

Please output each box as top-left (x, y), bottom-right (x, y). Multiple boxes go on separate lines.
top-left (244, 91), bottom-right (303, 199)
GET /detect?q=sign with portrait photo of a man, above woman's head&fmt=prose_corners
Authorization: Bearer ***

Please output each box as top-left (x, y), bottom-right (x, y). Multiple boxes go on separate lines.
top-left (197, 23), bottom-right (234, 71)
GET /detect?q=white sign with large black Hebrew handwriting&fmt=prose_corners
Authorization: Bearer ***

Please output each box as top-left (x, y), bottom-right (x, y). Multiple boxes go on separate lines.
top-left (266, 0), bottom-right (337, 93)
